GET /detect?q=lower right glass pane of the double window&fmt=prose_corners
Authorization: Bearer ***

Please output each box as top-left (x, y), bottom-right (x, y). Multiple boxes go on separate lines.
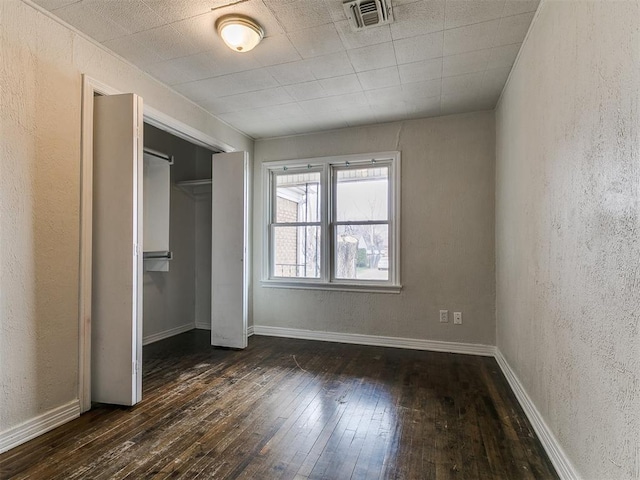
top-left (335, 225), bottom-right (389, 281)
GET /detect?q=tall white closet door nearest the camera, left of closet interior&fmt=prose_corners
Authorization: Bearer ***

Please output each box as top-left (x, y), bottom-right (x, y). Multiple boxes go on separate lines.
top-left (91, 94), bottom-right (143, 405)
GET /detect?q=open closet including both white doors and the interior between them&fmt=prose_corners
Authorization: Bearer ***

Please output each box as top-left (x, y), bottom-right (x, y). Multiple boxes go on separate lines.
top-left (91, 94), bottom-right (249, 405)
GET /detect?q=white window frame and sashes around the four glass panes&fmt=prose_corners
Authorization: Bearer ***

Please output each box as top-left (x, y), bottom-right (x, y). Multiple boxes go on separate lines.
top-left (261, 151), bottom-right (402, 293)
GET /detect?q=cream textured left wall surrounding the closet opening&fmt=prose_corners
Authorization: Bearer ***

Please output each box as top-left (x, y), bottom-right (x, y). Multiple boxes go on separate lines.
top-left (0, 0), bottom-right (252, 435)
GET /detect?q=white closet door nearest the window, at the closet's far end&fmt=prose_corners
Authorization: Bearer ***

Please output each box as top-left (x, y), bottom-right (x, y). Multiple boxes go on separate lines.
top-left (211, 152), bottom-right (249, 348)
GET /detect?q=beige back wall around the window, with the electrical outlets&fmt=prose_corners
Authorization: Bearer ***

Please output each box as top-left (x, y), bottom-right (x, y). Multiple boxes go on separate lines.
top-left (253, 113), bottom-right (495, 344)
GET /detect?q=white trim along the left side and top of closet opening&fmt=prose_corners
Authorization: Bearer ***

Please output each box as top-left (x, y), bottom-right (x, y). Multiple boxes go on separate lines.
top-left (78, 74), bottom-right (237, 413)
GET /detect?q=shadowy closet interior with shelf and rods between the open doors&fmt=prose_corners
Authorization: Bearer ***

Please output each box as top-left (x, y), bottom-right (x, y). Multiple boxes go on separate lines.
top-left (143, 123), bottom-right (216, 345)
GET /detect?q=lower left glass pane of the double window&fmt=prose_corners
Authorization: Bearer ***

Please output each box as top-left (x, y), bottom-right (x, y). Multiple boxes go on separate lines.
top-left (273, 226), bottom-right (320, 278)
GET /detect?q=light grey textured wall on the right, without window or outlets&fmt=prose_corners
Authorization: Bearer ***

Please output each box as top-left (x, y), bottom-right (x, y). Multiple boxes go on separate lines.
top-left (496, 1), bottom-right (640, 480)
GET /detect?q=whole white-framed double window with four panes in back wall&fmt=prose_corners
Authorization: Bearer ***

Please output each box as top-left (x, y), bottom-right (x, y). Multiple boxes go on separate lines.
top-left (263, 152), bottom-right (400, 291)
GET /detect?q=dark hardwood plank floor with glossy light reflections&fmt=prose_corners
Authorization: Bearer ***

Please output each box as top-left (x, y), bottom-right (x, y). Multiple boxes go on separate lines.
top-left (0, 330), bottom-right (558, 480)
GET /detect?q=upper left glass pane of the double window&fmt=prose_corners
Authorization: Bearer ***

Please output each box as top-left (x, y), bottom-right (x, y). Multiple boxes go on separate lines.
top-left (274, 172), bottom-right (320, 223)
